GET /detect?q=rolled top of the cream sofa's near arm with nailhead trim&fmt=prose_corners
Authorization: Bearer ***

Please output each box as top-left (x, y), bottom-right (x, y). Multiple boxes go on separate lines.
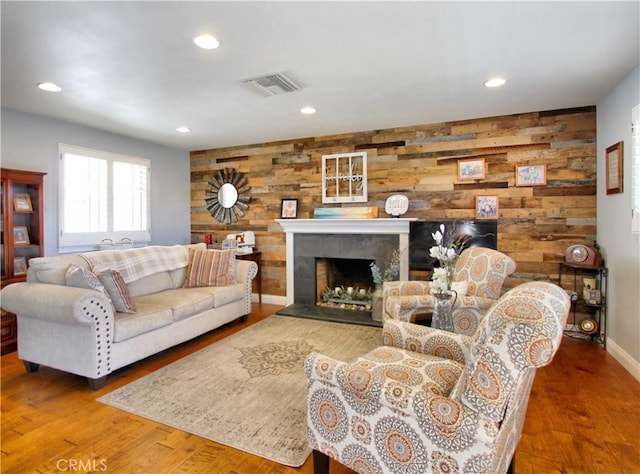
top-left (0, 282), bottom-right (113, 326)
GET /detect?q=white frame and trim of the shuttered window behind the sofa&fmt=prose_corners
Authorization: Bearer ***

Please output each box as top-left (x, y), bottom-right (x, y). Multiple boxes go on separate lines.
top-left (58, 143), bottom-right (151, 253)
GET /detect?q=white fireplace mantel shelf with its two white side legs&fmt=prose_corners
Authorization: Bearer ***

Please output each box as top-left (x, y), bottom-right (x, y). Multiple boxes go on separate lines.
top-left (276, 217), bottom-right (417, 305)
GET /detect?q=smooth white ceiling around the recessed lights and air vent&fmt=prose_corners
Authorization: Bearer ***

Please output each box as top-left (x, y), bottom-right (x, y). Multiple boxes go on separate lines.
top-left (0, 1), bottom-right (640, 150)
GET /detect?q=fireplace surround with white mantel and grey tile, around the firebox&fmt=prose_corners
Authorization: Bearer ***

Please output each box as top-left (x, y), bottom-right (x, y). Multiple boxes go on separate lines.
top-left (276, 218), bottom-right (416, 305)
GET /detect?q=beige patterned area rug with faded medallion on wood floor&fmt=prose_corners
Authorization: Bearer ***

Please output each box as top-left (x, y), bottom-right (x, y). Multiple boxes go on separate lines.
top-left (97, 314), bottom-right (381, 467)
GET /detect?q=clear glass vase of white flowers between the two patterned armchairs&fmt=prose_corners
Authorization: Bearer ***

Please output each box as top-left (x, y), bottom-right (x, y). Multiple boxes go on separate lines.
top-left (429, 224), bottom-right (469, 332)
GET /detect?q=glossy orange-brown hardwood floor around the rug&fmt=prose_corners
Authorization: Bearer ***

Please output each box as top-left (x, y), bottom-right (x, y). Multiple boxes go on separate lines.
top-left (0, 304), bottom-right (640, 474)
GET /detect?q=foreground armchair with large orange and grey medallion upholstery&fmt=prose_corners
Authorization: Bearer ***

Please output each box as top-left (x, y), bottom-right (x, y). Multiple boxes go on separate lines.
top-left (305, 282), bottom-right (570, 474)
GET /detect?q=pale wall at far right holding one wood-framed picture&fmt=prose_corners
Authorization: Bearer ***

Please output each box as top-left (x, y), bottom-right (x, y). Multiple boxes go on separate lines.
top-left (597, 67), bottom-right (640, 380)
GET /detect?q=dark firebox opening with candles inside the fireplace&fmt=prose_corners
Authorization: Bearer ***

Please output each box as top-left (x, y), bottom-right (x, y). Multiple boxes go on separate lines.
top-left (316, 258), bottom-right (375, 311)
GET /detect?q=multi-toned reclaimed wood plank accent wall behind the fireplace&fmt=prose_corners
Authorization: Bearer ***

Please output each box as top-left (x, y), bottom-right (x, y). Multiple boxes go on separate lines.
top-left (191, 106), bottom-right (597, 296)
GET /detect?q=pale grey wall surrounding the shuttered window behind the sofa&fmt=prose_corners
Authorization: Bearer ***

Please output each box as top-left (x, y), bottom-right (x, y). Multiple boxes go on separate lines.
top-left (0, 108), bottom-right (191, 256)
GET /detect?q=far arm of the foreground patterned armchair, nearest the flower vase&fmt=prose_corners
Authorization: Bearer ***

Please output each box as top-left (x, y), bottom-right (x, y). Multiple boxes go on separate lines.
top-left (382, 319), bottom-right (471, 364)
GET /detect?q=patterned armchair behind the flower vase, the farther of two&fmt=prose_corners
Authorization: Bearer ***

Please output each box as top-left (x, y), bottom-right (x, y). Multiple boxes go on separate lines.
top-left (382, 247), bottom-right (516, 336)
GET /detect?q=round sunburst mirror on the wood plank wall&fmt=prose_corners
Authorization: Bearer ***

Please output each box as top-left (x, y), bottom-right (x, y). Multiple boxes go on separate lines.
top-left (204, 168), bottom-right (251, 224)
